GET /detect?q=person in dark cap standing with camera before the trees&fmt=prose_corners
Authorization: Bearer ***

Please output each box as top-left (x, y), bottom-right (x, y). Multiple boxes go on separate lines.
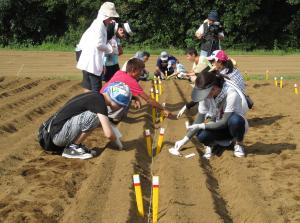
top-left (195, 10), bottom-right (224, 57)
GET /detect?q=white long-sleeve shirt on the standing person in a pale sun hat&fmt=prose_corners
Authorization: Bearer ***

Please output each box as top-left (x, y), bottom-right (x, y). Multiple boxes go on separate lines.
top-left (76, 13), bottom-right (113, 76)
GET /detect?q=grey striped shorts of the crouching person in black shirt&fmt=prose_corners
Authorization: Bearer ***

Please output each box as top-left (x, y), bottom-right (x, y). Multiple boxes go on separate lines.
top-left (53, 111), bottom-right (100, 146)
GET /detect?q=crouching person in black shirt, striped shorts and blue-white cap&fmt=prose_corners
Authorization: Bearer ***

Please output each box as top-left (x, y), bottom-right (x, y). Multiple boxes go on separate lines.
top-left (51, 82), bottom-right (132, 159)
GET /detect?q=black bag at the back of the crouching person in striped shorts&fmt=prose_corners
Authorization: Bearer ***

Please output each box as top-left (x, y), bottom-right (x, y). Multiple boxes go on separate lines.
top-left (38, 114), bottom-right (64, 153)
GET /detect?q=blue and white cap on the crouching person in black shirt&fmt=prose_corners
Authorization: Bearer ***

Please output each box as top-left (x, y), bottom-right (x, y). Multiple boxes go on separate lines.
top-left (104, 82), bottom-right (132, 106)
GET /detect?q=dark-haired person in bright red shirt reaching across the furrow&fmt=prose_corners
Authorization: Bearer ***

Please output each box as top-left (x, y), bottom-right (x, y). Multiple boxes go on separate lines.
top-left (100, 58), bottom-right (173, 118)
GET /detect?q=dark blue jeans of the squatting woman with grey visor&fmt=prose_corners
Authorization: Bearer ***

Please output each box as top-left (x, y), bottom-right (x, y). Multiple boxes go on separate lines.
top-left (197, 113), bottom-right (245, 146)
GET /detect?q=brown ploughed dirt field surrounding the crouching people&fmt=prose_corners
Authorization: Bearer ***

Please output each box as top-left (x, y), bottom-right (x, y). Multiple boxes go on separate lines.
top-left (0, 51), bottom-right (300, 223)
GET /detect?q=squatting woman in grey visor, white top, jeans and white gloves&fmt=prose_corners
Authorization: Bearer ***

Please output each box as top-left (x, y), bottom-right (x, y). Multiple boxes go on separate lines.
top-left (169, 70), bottom-right (249, 159)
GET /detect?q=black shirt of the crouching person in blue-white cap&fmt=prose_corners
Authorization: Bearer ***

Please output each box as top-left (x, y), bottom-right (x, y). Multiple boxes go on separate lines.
top-left (51, 92), bottom-right (108, 136)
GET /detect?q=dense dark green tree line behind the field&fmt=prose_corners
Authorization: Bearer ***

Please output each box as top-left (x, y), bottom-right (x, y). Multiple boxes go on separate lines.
top-left (0, 0), bottom-right (300, 50)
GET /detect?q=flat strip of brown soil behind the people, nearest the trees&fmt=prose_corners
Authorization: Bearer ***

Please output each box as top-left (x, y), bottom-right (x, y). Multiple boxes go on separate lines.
top-left (0, 50), bottom-right (300, 80)
